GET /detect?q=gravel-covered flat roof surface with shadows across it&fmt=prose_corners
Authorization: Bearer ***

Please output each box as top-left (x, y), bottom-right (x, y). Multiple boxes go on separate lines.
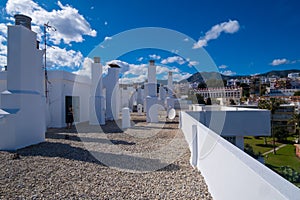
top-left (0, 113), bottom-right (212, 199)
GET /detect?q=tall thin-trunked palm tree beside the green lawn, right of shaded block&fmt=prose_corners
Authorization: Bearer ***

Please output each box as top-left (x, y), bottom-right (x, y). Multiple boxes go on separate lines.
top-left (258, 98), bottom-right (280, 154)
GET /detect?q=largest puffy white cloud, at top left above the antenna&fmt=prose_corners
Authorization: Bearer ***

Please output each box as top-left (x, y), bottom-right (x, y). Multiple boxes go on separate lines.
top-left (6, 0), bottom-right (97, 45)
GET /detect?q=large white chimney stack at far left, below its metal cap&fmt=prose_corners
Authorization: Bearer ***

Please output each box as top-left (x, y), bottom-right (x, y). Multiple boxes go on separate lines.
top-left (0, 25), bottom-right (46, 150)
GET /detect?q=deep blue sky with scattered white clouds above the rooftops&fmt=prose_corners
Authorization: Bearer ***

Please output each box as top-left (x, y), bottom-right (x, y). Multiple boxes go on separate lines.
top-left (0, 0), bottom-right (300, 82)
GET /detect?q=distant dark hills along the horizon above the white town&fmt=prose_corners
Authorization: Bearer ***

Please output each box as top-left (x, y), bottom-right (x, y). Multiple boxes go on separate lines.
top-left (180, 69), bottom-right (300, 82)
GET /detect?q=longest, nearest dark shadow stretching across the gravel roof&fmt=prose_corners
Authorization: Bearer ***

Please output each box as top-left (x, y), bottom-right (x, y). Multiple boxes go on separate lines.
top-left (17, 142), bottom-right (179, 173)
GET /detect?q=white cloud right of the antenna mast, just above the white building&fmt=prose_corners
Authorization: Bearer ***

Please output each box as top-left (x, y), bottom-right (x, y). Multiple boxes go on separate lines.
top-left (47, 46), bottom-right (83, 69)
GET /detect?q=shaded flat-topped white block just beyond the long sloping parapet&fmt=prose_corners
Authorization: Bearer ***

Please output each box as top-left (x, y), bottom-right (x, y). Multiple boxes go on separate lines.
top-left (188, 105), bottom-right (271, 136)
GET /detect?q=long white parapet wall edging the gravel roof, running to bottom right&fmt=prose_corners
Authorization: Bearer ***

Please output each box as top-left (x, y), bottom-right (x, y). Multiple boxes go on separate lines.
top-left (180, 111), bottom-right (300, 200)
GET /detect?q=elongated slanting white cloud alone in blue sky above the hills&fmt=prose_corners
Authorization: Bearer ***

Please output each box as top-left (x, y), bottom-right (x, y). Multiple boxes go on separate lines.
top-left (193, 20), bottom-right (240, 49)
